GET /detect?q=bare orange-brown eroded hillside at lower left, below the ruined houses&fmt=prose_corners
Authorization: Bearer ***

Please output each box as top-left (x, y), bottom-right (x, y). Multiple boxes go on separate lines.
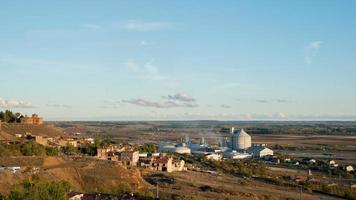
top-left (0, 157), bottom-right (149, 194)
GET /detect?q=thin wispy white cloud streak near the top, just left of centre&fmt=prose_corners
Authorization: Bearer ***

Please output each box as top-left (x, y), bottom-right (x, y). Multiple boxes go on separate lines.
top-left (121, 20), bottom-right (171, 31)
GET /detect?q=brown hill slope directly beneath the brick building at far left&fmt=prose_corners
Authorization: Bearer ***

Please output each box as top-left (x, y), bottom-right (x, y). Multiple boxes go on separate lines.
top-left (0, 123), bottom-right (65, 140)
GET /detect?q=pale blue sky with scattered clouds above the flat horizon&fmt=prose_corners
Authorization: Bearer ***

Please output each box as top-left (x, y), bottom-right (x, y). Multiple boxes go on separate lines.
top-left (0, 0), bottom-right (356, 120)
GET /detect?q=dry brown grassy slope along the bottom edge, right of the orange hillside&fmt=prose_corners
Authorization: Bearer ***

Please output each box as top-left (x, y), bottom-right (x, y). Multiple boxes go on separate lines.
top-left (153, 171), bottom-right (338, 200)
